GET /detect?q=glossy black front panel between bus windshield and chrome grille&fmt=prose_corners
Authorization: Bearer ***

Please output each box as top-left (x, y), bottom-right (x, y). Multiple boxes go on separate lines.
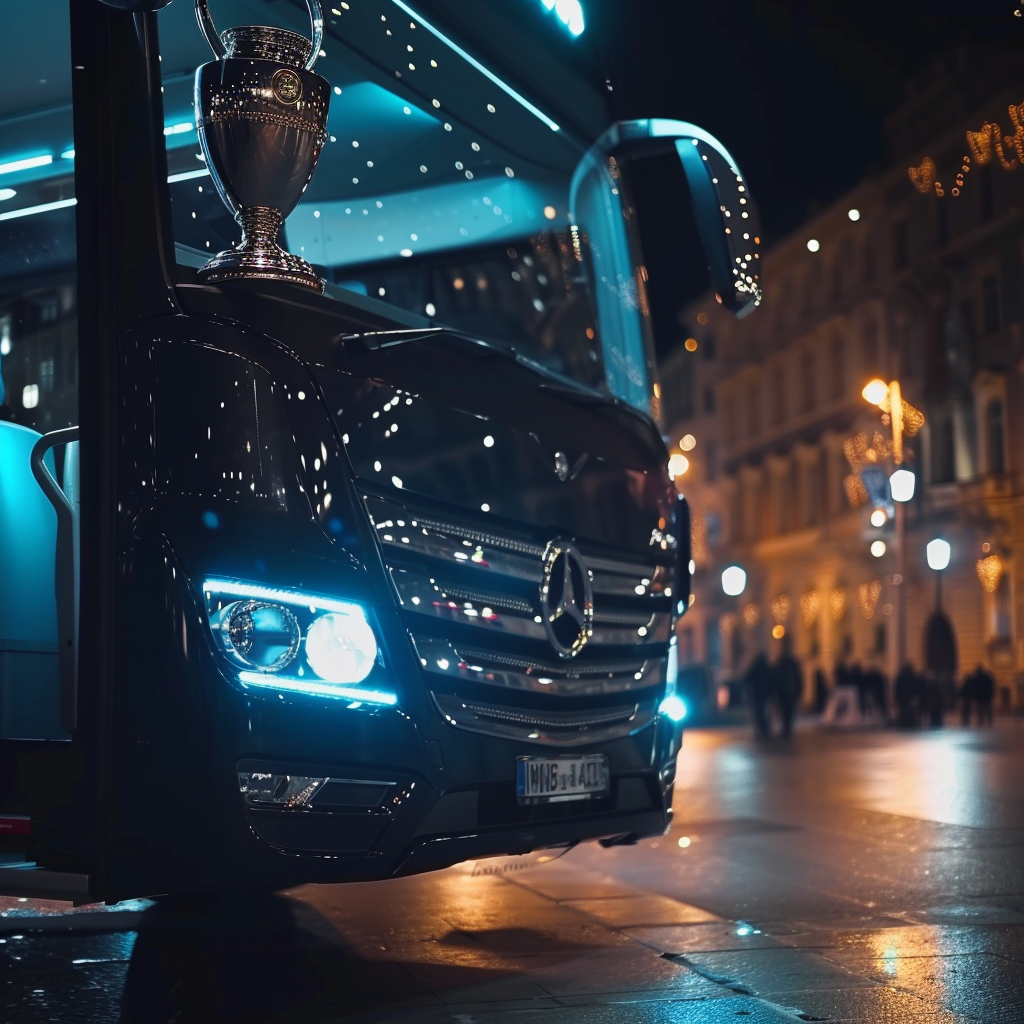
top-left (313, 333), bottom-right (675, 552)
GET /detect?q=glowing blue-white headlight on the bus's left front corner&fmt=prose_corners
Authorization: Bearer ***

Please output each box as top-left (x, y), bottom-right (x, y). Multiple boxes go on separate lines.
top-left (203, 580), bottom-right (398, 705)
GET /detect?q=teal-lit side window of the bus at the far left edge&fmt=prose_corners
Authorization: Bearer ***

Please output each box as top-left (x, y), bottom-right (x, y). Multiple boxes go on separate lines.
top-left (0, 0), bottom-right (78, 739)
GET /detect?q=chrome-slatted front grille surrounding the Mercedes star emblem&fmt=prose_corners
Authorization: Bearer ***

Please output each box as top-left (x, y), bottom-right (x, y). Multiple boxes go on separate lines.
top-left (362, 494), bottom-right (675, 746)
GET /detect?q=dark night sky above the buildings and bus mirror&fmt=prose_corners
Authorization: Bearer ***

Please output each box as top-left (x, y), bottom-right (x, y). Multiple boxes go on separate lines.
top-left (585, 0), bottom-right (1024, 349)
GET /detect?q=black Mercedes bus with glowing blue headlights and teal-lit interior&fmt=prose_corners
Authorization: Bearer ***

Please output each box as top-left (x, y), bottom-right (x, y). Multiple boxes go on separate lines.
top-left (0, 0), bottom-right (760, 901)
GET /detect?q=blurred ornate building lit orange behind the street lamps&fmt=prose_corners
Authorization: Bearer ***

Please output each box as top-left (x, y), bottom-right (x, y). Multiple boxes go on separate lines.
top-left (662, 52), bottom-right (1024, 712)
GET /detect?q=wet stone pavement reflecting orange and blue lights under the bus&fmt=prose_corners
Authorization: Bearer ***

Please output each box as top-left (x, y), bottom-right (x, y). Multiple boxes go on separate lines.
top-left (0, 722), bottom-right (1024, 1024)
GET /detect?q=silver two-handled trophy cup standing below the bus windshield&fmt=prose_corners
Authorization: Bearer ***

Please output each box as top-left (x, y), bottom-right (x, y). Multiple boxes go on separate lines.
top-left (196, 0), bottom-right (331, 292)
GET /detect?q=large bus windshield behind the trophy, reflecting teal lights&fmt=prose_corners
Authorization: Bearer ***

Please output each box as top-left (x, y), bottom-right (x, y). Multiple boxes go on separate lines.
top-left (159, 0), bottom-right (608, 390)
